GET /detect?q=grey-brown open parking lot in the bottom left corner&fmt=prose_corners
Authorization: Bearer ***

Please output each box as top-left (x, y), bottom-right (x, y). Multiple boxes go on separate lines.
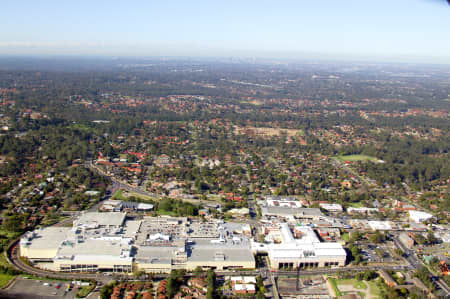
top-left (0, 277), bottom-right (77, 299)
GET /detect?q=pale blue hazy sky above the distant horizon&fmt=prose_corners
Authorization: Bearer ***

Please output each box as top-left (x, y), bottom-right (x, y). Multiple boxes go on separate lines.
top-left (0, 0), bottom-right (450, 64)
